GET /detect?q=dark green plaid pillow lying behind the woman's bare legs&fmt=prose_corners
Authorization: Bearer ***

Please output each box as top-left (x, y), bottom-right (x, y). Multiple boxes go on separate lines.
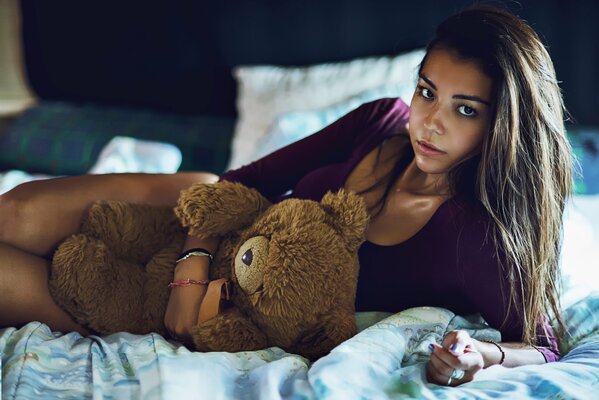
top-left (0, 101), bottom-right (235, 175)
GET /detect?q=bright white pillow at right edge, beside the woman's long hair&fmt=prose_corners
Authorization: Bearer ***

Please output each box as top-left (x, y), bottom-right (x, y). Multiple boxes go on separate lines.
top-left (560, 195), bottom-right (599, 308)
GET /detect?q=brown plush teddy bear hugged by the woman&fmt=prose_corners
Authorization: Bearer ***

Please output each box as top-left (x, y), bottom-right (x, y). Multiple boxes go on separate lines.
top-left (49, 181), bottom-right (368, 359)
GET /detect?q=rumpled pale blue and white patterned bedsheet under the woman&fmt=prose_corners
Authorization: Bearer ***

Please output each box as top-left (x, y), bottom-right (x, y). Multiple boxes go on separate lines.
top-left (0, 292), bottom-right (599, 400)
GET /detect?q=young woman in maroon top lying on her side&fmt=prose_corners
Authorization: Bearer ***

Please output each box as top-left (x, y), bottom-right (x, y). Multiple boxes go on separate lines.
top-left (0, 6), bottom-right (572, 386)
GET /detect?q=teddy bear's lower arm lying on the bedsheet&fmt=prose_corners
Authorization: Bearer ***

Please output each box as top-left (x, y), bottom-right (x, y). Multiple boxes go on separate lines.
top-left (192, 310), bottom-right (267, 352)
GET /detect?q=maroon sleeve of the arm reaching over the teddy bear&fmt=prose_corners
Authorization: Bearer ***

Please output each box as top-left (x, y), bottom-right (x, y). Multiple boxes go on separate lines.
top-left (220, 99), bottom-right (409, 198)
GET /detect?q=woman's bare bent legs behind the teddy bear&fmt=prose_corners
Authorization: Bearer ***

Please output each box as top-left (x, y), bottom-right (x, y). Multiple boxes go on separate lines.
top-left (0, 173), bottom-right (218, 334)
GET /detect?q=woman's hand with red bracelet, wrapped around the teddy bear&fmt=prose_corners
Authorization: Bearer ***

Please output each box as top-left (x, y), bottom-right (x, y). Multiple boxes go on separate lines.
top-left (164, 257), bottom-right (209, 345)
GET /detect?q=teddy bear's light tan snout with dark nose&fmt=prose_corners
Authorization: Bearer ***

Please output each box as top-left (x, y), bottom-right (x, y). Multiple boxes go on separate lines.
top-left (235, 236), bottom-right (269, 295)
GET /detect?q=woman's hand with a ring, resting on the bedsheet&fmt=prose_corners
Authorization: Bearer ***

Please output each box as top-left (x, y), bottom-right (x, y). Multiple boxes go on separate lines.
top-left (426, 330), bottom-right (484, 386)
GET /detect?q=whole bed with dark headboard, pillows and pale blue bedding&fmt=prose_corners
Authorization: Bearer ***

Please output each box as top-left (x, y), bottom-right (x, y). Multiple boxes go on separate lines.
top-left (0, 0), bottom-right (599, 400)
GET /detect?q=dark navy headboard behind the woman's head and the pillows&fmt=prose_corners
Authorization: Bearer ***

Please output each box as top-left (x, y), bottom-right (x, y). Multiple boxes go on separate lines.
top-left (21, 0), bottom-right (599, 125)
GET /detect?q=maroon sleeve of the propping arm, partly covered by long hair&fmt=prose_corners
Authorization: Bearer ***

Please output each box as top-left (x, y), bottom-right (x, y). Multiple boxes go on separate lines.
top-left (458, 212), bottom-right (560, 362)
